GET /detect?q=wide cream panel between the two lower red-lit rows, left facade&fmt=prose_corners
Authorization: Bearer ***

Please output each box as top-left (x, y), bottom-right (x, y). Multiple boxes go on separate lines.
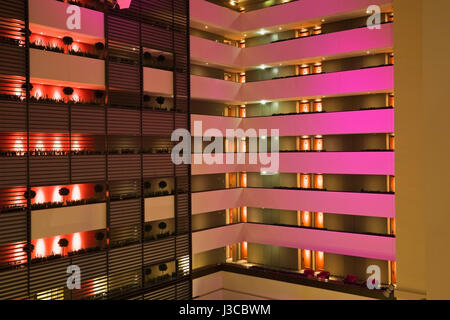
top-left (31, 203), bottom-right (106, 239)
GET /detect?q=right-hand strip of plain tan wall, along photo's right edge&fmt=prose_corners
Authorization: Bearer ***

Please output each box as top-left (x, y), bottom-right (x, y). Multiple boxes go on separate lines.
top-left (422, 0), bottom-right (450, 299)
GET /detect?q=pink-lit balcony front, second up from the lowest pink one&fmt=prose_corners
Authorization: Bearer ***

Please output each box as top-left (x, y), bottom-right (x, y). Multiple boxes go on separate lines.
top-left (192, 188), bottom-right (395, 218)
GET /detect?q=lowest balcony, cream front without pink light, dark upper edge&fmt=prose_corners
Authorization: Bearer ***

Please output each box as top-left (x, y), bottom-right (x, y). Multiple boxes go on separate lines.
top-left (193, 263), bottom-right (393, 300)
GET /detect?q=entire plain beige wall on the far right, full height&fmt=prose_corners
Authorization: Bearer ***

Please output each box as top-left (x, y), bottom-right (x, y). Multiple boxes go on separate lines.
top-left (394, 0), bottom-right (450, 299)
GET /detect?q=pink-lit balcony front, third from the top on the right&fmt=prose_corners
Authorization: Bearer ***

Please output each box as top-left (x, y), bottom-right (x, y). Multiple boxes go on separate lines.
top-left (190, 66), bottom-right (394, 104)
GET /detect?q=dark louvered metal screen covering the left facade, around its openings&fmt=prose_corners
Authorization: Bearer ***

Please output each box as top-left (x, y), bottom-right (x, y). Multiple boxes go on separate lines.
top-left (0, 0), bottom-right (192, 299)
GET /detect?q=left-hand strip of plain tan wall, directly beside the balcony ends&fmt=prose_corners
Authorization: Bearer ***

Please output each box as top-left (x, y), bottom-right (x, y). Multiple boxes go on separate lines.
top-left (394, 0), bottom-right (428, 298)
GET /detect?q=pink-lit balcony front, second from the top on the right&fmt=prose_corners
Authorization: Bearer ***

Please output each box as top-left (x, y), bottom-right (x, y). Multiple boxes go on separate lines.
top-left (191, 23), bottom-right (394, 70)
